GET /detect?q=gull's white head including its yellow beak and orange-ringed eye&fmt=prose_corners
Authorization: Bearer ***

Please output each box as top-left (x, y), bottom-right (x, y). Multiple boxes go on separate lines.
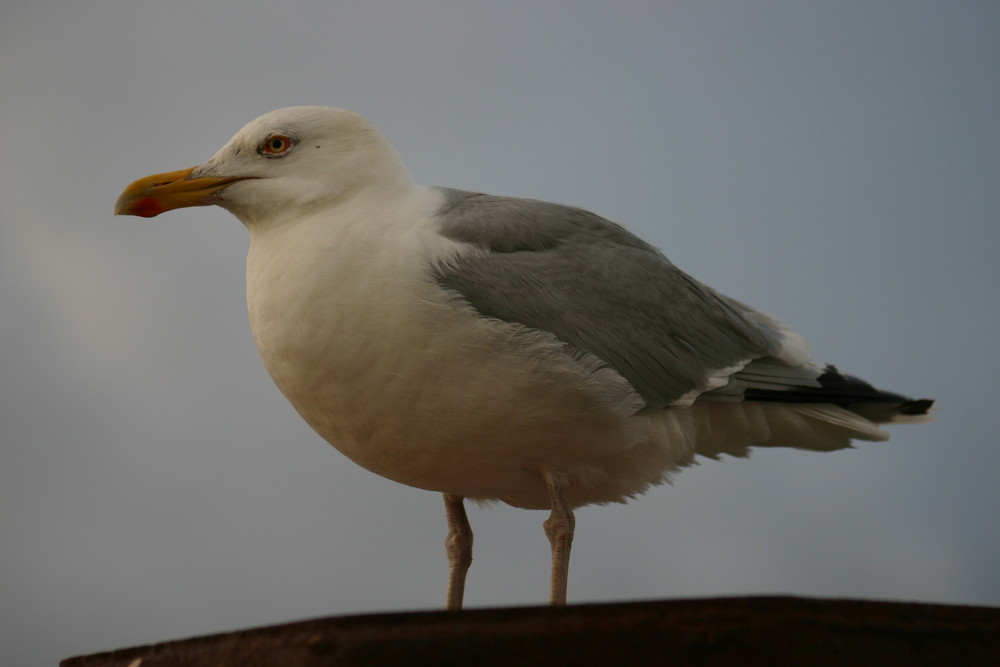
top-left (115, 107), bottom-right (412, 226)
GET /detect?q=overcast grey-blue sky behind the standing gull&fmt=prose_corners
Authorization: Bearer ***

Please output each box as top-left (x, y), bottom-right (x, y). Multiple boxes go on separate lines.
top-left (0, 0), bottom-right (1000, 665)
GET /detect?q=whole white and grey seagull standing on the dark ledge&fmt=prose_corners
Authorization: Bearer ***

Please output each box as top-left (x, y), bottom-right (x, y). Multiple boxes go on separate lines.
top-left (115, 107), bottom-right (933, 609)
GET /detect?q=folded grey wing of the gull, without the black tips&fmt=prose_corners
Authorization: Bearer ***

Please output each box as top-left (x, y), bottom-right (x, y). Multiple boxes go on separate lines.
top-left (435, 189), bottom-right (785, 407)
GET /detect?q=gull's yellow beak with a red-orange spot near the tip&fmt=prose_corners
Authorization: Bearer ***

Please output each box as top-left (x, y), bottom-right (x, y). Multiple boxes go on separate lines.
top-left (115, 167), bottom-right (247, 218)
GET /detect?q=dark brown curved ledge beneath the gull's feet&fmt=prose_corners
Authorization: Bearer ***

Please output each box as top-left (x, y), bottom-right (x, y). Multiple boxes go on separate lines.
top-left (61, 597), bottom-right (1000, 667)
